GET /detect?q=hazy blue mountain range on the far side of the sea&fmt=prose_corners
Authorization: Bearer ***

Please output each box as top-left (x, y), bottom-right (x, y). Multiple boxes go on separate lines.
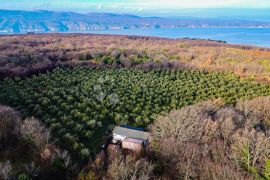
top-left (0, 10), bottom-right (270, 33)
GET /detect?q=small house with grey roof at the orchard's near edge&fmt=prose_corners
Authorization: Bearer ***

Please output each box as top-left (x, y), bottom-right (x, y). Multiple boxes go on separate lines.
top-left (112, 126), bottom-right (150, 152)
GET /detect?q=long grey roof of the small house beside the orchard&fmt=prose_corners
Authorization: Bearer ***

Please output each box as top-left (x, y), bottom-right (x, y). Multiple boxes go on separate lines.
top-left (113, 126), bottom-right (150, 141)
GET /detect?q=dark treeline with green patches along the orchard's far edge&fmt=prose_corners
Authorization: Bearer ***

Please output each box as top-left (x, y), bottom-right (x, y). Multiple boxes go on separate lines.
top-left (0, 49), bottom-right (192, 79)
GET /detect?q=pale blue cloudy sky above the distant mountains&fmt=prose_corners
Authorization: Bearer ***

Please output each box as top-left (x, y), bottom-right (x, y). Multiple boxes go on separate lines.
top-left (0, 0), bottom-right (270, 16)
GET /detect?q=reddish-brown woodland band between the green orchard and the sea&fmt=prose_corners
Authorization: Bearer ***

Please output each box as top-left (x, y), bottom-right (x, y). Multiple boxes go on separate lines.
top-left (0, 34), bottom-right (270, 80)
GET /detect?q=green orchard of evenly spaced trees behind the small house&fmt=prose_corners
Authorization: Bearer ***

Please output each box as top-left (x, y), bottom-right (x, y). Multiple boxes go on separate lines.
top-left (0, 68), bottom-right (270, 158)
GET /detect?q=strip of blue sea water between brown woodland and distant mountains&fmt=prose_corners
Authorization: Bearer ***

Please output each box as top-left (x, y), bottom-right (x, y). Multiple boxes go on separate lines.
top-left (88, 28), bottom-right (270, 47)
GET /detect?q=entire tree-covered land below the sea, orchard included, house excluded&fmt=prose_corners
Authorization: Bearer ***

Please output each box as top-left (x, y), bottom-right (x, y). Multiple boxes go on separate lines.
top-left (0, 34), bottom-right (270, 180)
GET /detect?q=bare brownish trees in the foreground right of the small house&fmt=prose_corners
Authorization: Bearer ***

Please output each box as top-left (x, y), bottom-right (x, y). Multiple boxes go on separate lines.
top-left (152, 97), bottom-right (270, 180)
